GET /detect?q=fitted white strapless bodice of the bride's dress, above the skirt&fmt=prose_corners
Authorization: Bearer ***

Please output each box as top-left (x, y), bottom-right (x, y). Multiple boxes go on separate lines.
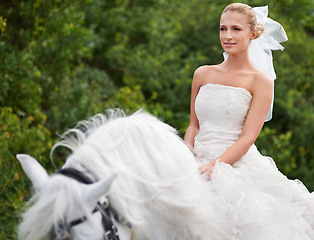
top-left (194, 83), bottom-right (252, 160)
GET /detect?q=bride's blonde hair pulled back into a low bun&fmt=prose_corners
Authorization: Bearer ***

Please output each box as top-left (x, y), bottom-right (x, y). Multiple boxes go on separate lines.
top-left (222, 3), bottom-right (264, 38)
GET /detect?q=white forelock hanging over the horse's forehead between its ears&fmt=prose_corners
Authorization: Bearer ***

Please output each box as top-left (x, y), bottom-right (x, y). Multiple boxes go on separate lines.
top-left (19, 176), bottom-right (101, 240)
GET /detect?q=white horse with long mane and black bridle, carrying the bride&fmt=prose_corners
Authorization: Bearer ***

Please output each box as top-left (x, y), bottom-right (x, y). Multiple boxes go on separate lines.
top-left (17, 110), bottom-right (228, 240)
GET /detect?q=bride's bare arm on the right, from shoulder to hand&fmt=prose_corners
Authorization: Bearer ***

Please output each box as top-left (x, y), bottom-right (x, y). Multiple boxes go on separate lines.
top-left (201, 75), bottom-right (274, 176)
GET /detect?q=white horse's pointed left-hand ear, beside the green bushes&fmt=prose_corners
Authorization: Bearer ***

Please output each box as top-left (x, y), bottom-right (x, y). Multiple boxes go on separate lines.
top-left (16, 154), bottom-right (49, 191)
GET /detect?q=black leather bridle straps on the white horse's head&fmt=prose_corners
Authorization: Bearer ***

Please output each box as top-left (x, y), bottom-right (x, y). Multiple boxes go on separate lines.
top-left (51, 168), bottom-right (132, 240)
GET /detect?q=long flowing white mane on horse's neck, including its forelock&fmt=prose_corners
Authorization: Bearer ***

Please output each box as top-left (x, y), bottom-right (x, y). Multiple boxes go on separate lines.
top-left (21, 110), bottom-right (225, 240)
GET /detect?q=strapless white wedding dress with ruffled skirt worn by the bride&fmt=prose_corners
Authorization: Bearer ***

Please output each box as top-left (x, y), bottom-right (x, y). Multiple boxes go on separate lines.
top-left (194, 83), bottom-right (314, 240)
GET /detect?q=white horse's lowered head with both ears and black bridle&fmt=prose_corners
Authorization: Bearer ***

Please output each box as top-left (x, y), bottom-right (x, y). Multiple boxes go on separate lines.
top-left (17, 154), bottom-right (129, 240)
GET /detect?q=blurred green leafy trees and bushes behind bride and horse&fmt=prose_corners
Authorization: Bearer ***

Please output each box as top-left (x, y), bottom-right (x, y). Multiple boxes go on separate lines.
top-left (0, 0), bottom-right (314, 239)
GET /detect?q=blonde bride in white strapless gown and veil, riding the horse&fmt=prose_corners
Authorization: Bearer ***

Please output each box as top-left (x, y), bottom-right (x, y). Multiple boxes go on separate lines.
top-left (184, 3), bottom-right (314, 240)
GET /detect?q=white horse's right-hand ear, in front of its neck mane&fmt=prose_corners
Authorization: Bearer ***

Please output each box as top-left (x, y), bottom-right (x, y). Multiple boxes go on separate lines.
top-left (84, 173), bottom-right (116, 201)
